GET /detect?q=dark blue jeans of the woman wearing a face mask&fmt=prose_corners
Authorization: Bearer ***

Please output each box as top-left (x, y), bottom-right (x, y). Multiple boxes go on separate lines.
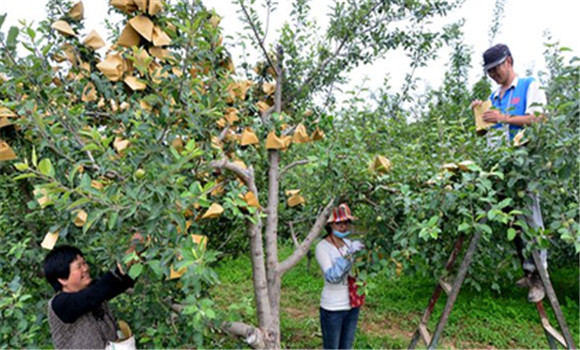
top-left (320, 307), bottom-right (359, 349)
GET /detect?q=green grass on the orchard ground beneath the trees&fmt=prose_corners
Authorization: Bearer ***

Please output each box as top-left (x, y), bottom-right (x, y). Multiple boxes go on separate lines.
top-left (213, 247), bottom-right (579, 349)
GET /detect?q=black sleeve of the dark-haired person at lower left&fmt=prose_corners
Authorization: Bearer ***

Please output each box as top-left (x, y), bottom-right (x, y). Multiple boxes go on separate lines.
top-left (52, 272), bottom-right (135, 323)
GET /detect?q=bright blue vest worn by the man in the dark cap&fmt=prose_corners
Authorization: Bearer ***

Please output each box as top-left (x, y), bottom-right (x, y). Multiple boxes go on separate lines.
top-left (489, 77), bottom-right (534, 140)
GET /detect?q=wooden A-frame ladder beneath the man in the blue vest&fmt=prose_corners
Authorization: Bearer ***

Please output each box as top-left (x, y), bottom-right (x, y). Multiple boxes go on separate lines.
top-left (408, 232), bottom-right (576, 349)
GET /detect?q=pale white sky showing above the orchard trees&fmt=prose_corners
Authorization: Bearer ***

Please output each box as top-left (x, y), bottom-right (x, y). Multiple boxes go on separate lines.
top-left (0, 0), bottom-right (580, 102)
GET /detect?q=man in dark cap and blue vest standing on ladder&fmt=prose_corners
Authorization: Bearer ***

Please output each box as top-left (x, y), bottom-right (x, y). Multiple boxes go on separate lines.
top-left (471, 44), bottom-right (548, 303)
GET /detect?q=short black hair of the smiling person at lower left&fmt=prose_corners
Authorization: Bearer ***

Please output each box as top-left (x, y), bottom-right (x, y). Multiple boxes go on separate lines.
top-left (44, 245), bottom-right (83, 292)
